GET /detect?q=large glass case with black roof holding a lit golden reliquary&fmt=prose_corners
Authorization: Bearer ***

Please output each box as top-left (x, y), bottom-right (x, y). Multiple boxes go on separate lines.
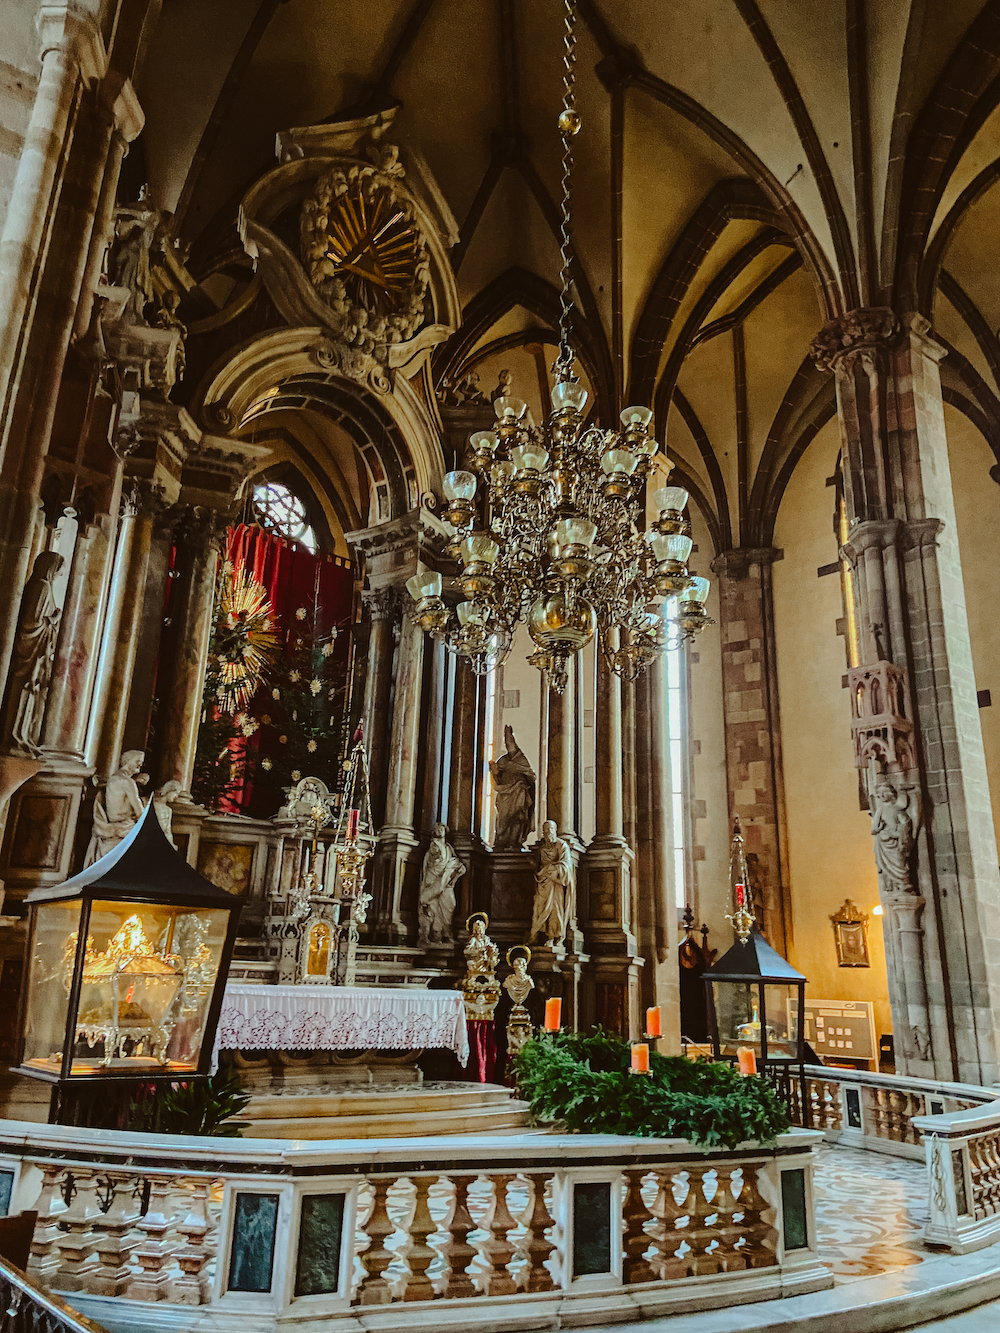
top-left (19, 805), bottom-right (239, 1103)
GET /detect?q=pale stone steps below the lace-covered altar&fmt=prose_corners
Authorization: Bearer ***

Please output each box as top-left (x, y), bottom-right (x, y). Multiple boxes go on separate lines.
top-left (239, 1084), bottom-right (528, 1140)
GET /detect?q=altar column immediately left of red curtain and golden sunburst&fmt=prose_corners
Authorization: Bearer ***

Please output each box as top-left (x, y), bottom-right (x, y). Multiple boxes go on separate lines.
top-left (156, 507), bottom-right (223, 794)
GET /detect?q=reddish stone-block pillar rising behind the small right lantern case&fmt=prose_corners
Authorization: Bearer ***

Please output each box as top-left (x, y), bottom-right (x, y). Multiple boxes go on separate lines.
top-left (712, 547), bottom-right (792, 954)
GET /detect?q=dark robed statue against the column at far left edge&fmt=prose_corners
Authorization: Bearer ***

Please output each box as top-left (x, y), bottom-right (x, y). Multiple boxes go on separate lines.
top-left (4, 551), bottom-right (63, 754)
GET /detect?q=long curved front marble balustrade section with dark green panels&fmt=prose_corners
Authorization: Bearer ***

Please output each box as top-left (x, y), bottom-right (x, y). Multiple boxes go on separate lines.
top-left (0, 1121), bottom-right (832, 1330)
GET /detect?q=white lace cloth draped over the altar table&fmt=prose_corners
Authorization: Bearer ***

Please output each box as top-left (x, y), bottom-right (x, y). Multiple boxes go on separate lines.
top-left (212, 982), bottom-right (469, 1069)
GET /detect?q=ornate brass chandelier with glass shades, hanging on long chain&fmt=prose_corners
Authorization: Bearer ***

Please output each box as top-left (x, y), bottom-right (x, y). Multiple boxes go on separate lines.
top-left (407, 0), bottom-right (712, 693)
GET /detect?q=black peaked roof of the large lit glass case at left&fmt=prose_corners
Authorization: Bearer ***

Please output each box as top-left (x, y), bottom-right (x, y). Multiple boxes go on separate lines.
top-left (25, 800), bottom-right (240, 912)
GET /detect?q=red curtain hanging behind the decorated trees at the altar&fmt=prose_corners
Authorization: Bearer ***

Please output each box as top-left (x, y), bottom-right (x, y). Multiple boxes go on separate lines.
top-left (221, 524), bottom-right (355, 817)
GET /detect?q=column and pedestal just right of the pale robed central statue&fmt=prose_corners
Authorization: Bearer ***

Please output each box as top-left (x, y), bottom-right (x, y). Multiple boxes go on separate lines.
top-left (579, 647), bottom-right (643, 1036)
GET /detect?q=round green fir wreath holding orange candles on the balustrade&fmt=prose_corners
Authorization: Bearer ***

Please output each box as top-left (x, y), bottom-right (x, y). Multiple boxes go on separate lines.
top-left (515, 1029), bottom-right (791, 1148)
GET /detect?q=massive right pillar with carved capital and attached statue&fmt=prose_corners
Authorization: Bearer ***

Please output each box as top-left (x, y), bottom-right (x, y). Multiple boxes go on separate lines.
top-left (813, 309), bottom-right (1000, 1085)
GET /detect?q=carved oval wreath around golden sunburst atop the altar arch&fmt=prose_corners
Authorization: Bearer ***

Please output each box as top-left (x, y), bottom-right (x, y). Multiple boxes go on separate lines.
top-left (300, 144), bottom-right (431, 375)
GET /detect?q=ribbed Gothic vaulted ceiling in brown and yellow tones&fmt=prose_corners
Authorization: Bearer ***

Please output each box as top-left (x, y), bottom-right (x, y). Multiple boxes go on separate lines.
top-left (133, 0), bottom-right (1000, 549)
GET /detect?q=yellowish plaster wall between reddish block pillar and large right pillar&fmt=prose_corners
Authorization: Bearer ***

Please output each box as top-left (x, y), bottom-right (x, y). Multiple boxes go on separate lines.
top-left (773, 421), bottom-right (892, 1033)
